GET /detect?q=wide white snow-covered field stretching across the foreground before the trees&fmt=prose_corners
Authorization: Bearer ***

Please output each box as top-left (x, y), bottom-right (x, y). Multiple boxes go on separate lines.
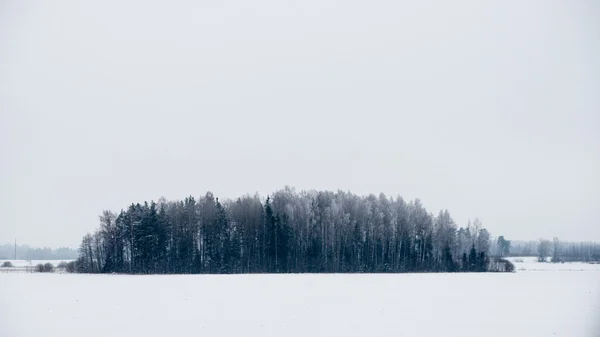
top-left (0, 258), bottom-right (600, 337)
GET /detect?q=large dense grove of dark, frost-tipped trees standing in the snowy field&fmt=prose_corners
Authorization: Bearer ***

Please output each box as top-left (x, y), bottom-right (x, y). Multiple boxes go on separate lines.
top-left (76, 187), bottom-right (506, 274)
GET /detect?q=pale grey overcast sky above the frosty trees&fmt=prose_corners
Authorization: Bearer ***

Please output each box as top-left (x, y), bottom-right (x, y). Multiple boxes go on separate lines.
top-left (0, 0), bottom-right (600, 247)
